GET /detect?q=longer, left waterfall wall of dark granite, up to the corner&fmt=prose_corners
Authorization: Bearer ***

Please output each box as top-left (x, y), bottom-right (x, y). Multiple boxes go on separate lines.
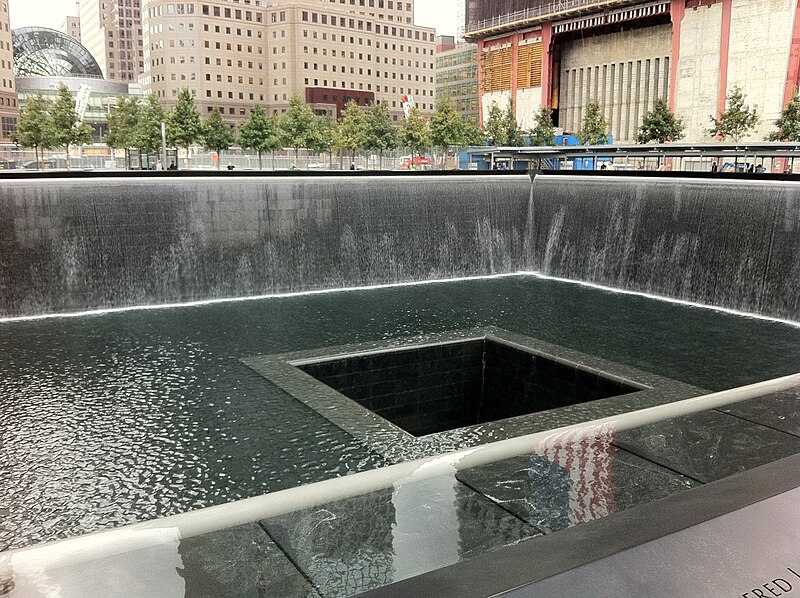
top-left (0, 175), bottom-right (530, 316)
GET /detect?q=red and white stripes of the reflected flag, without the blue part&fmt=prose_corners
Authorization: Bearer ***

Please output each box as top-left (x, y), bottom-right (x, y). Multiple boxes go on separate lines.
top-left (539, 429), bottom-right (617, 525)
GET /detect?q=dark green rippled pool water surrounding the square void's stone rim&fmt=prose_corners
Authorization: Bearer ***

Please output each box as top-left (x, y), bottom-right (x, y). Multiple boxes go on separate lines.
top-left (0, 277), bottom-right (800, 550)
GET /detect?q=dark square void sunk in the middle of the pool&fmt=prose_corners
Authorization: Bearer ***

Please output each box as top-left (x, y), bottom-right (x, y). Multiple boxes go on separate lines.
top-left (296, 338), bottom-right (647, 436)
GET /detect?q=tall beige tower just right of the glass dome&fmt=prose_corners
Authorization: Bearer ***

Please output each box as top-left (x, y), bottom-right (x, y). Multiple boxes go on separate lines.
top-left (80, 0), bottom-right (145, 83)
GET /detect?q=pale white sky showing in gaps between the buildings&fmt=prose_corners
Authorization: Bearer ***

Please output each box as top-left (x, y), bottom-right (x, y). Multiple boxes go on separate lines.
top-left (10, 0), bottom-right (458, 35)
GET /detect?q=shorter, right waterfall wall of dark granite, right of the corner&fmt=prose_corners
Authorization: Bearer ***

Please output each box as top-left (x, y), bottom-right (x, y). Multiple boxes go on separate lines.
top-left (526, 176), bottom-right (800, 320)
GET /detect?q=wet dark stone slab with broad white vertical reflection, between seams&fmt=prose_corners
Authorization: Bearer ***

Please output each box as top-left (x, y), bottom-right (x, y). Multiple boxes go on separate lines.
top-left (262, 474), bottom-right (538, 598)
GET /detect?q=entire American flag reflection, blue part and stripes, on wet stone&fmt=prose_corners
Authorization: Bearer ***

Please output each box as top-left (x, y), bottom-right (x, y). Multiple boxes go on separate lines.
top-left (528, 425), bottom-right (617, 529)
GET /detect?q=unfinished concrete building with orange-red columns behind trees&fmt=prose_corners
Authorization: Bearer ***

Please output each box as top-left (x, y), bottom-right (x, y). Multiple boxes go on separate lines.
top-left (465, 0), bottom-right (800, 142)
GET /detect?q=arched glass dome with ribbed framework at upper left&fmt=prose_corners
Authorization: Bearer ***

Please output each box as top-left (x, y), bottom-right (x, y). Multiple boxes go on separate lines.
top-left (11, 27), bottom-right (103, 79)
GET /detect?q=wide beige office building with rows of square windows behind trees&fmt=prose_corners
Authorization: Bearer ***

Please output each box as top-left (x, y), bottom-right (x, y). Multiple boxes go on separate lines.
top-left (142, 0), bottom-right (435, 122)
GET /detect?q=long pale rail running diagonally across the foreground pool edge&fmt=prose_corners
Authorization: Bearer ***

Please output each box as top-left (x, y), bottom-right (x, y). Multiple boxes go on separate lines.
top-left (0, 373), bottom-right (800, 570)
